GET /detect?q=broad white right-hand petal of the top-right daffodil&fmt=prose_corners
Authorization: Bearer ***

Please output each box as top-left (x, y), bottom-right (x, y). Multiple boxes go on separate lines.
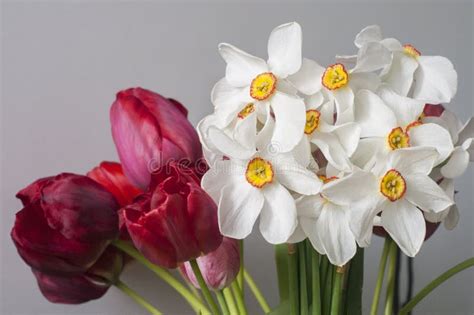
top-left (413, 56), bottom-right (458, 104)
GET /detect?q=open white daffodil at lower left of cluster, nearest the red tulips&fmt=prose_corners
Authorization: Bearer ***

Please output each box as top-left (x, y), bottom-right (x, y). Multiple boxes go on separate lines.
top-left (202, 127), bottom-right (322, 244)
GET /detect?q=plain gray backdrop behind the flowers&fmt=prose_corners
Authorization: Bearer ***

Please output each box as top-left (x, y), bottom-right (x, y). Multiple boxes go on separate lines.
top-left (0, 0), bottom-right (474, 315)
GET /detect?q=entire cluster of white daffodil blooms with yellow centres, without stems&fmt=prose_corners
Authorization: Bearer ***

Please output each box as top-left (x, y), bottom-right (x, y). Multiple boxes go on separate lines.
top-left (198, 23), bottom-right (474, 266)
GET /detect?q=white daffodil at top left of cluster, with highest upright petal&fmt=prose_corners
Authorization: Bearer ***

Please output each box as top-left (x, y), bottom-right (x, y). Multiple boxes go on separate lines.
top-left (211, 22), bottom-right (305, 152)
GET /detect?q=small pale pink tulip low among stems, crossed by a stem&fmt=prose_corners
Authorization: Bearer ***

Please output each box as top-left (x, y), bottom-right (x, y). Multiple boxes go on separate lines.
top-left (180, 237), bottom-right (240, 290)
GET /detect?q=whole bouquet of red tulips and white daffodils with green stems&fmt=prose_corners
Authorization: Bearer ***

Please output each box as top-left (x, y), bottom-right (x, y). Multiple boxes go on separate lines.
top-left (11, 22), bottom-right (474, 315)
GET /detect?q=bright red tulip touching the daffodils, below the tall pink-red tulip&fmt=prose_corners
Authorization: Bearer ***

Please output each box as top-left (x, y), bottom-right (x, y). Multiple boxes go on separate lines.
top-left (120, 163), bottom-right (222, 268)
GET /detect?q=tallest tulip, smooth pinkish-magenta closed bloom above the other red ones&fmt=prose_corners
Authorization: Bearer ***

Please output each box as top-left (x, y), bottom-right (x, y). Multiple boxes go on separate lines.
top-left (110, 88), bottom-right (202, 190)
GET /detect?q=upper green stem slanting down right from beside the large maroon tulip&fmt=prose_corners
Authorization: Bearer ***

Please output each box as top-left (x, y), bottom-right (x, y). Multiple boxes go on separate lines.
top-left (112, 240), bottom-right (210, 314)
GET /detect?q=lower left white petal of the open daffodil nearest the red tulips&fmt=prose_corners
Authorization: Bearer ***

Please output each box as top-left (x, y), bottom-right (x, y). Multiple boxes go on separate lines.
top-left (218, 179), bottom-right (264, 239)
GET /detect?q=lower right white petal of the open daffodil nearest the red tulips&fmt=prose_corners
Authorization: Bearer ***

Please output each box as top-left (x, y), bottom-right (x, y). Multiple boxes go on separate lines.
top-left (260, 182), bottom-right (298, 244)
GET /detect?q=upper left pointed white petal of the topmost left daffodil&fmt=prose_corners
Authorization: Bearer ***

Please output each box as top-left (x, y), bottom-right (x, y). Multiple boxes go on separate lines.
top-left (218, 43), bottom-right (268, 87)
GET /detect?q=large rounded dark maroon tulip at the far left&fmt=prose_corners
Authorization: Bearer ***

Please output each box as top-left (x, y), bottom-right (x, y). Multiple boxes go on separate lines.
top-left (11, 174), bottom-right (119, 273)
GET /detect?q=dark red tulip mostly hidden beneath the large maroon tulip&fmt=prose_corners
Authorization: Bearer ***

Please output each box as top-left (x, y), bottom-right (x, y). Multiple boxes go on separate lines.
top-left (33, 247), bottom-right (123, 304)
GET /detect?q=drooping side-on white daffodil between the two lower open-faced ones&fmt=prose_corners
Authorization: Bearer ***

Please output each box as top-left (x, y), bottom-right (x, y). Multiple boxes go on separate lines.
top-left (291, 171), bottom-right (374, 266)
